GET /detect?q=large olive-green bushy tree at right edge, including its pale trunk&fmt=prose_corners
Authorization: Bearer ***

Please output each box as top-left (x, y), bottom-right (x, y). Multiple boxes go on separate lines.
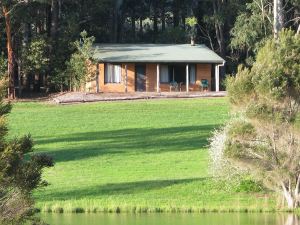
top-left (219, 30), bottom-right (300, 208)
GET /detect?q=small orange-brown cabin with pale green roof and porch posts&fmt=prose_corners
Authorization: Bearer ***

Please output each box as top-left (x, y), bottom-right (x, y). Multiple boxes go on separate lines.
top-left (89, 44), bottom-right (225, 92)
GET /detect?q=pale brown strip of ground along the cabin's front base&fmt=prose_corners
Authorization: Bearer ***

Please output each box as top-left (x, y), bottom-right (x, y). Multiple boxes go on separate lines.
top-left (52, 92), bottom-right (226, 104)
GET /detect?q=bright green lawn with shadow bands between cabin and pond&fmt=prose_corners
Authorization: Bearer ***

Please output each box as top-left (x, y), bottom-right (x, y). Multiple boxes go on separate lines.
top-left (9, 98), bottom-right (273, 212)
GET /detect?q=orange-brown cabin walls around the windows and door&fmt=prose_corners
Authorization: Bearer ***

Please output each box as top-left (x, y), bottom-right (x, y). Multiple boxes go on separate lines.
top-left (93, 63), bottom-right (212, 93)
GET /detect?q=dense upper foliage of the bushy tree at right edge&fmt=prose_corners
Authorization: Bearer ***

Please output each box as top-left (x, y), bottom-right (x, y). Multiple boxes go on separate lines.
top-left (227, 30), bottom-right (300, 122)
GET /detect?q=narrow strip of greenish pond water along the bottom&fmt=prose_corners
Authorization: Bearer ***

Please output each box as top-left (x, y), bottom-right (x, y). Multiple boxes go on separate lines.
top-left (41, 213), bottom-right (300, 225)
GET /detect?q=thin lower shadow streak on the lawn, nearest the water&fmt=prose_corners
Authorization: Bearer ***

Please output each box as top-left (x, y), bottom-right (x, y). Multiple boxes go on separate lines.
top-left (38, 178), bottom-right (210, 201)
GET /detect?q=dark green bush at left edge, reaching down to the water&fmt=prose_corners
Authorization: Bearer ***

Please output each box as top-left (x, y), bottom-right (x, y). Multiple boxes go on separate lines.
top-left (0, 83), bottom-right (53, 223)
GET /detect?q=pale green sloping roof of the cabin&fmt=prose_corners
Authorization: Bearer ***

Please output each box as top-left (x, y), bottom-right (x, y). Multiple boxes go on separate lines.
top-left (93, 44), bottom-right (225, 64)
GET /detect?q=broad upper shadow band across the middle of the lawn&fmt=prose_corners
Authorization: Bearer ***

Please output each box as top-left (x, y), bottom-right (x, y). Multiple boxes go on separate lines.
top-left (35, 125), bottom-right (216, 162)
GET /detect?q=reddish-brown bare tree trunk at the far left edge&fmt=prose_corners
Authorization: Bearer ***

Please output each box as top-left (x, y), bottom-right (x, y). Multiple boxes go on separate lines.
top-left (0, 5), bottom-right (16, 99)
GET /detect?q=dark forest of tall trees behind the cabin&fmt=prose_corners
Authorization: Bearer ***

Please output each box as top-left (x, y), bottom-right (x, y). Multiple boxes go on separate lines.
top-left (0, 0), bottom-right (300, 98)
